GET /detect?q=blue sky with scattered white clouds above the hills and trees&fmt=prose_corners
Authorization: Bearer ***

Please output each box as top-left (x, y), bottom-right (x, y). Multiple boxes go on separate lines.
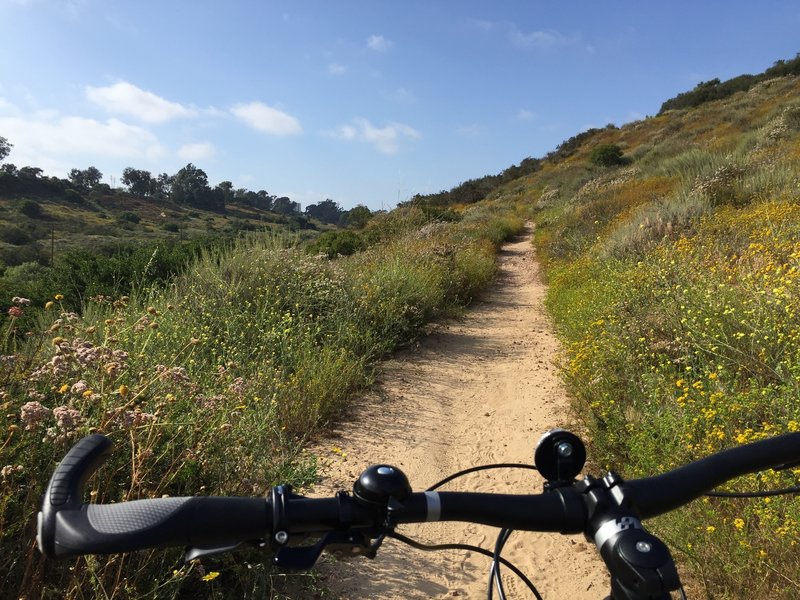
top-left (0, 0), bottom-right (800, 209)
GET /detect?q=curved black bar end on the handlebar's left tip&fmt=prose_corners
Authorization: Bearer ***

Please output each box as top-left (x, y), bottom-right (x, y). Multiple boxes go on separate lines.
top-left (36, 434), bottom-right (112, 556)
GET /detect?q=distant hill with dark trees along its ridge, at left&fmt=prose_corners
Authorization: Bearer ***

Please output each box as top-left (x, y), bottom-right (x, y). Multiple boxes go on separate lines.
top-left (0, 163), bottom-right (316, 268)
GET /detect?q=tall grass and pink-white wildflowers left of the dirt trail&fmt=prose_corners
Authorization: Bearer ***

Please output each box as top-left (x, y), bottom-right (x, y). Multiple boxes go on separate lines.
top-left (0, 208), bottom-right (522, 598)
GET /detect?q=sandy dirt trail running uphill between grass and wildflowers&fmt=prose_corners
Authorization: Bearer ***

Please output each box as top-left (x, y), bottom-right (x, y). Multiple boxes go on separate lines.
top-left (312, 227), bottom-right (608, 600)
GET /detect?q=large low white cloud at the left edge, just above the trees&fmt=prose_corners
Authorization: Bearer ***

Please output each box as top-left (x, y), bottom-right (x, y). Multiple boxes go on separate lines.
top-left (0, 103), bottom-right (167, 176)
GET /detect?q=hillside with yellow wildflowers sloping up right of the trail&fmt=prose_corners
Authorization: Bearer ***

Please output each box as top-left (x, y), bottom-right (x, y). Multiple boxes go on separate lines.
top-left (500, 77), bottom-right (800, 599)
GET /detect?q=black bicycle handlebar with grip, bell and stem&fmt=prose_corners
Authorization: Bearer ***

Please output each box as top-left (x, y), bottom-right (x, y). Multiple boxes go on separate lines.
top-left (37, 433), bottom-right (800, 598)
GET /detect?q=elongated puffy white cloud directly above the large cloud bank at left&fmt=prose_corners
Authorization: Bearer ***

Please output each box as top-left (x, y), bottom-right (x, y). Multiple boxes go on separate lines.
top-left (86, 81), bottom-right (198, 123)
